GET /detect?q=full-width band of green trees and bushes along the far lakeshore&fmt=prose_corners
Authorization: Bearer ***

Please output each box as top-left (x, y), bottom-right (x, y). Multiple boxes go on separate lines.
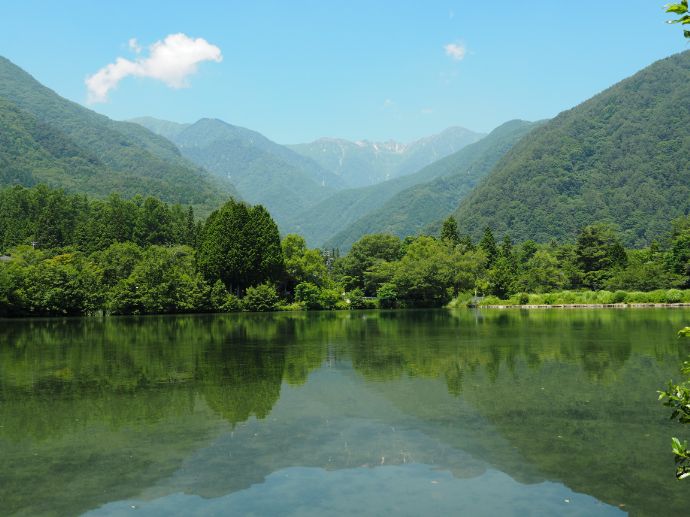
top-left (0, 186), bottom-right (690, 316)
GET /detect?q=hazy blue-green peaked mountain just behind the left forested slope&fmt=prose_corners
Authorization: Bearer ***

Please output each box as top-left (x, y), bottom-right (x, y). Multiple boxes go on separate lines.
top-left (135, 117), bottom-right (344, 228)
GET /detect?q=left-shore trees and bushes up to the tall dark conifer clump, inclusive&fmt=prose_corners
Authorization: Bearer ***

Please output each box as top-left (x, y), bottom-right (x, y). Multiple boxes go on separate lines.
top-left (0, 185), bottom-right (282, 315)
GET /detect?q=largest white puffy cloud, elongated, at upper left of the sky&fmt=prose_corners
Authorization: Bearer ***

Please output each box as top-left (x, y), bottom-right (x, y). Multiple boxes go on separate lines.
top-left (85, 33), bottom-right (223, 103)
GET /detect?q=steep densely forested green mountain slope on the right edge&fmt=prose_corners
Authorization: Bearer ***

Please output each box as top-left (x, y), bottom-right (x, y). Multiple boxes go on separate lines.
top-left (448, 51), bottom-right (690, 246)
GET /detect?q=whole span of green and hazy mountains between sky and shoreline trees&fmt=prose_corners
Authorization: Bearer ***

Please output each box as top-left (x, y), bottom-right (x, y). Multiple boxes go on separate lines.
top-left (0, 51), bottom-right (690, 251)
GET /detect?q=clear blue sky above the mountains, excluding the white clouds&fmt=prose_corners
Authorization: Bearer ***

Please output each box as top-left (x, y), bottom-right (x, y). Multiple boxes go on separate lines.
top-left (0, 0), bottom-right (690, 143)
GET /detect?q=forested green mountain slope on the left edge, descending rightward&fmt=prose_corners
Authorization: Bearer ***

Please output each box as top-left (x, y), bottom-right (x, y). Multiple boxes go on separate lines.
top-left (0, 57), bottom-right (238, 211)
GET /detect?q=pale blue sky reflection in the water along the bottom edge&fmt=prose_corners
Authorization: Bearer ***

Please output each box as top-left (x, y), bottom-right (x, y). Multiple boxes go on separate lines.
top-left (86, 464), bottom-right (623, 516)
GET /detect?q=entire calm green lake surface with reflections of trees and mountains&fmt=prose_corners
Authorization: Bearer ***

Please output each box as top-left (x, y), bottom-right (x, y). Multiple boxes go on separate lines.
top-left (0, 310), bottom-right (690, 516)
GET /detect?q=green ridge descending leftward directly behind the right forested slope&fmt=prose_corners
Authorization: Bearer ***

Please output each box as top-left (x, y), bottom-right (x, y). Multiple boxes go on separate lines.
top-left (324, 120), bottom-right (542, 250)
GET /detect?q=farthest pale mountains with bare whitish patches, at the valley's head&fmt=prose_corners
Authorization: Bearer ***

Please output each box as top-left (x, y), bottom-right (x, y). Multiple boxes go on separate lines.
top-left (288, 127), bottom-right (484, 187)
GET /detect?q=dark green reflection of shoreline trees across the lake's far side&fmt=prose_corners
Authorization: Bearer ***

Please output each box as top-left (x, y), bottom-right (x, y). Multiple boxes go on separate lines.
top-left (0, 311), bottom-right (682, 437)
